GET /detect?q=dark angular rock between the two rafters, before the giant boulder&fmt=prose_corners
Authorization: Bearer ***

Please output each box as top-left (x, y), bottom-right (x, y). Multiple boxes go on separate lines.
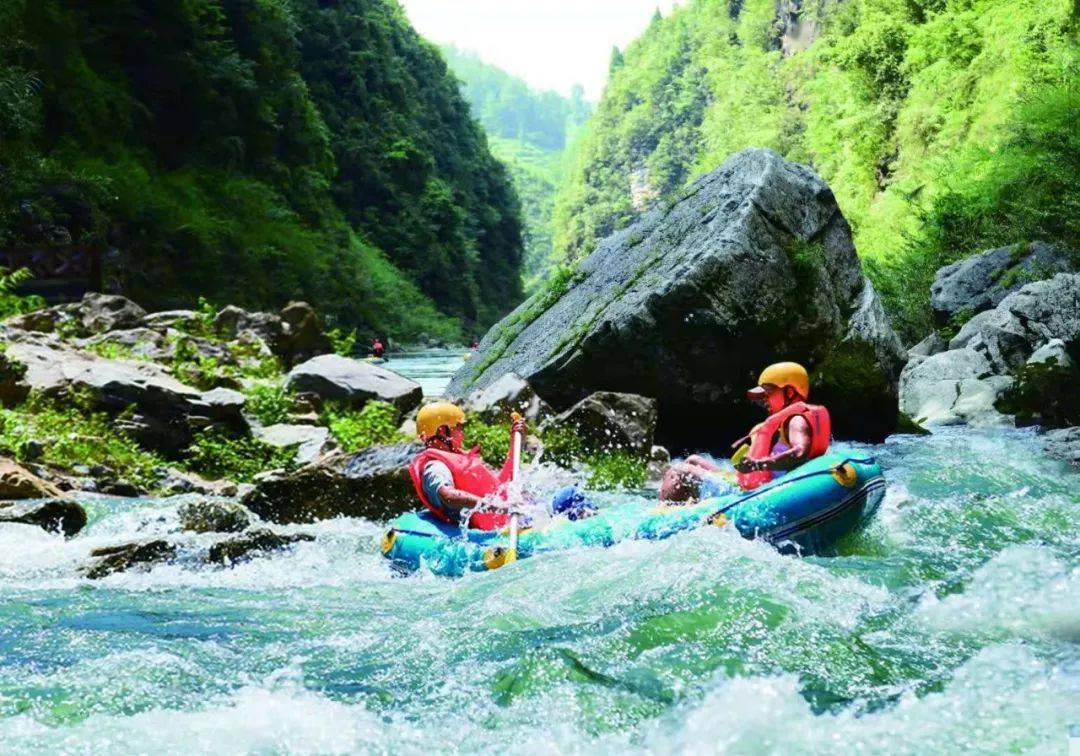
top-left (543, 391), bottom-right (657, 457)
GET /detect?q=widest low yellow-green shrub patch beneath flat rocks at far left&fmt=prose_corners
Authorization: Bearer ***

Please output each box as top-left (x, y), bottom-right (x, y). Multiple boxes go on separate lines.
top-left (0, 394), bottom-right (165, 488)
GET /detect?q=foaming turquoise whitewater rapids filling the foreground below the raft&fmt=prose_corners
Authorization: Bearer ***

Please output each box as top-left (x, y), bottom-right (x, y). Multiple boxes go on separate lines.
top-left (0, 425), bottom-right (1080, 754)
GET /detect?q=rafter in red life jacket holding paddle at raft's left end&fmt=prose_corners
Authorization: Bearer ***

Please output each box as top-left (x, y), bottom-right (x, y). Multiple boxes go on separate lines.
top-left (409, 402), bottom-right (596, 530)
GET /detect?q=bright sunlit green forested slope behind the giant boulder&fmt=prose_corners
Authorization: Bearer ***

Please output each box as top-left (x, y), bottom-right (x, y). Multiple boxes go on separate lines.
top-left (555, 0), bottom-right (1080, 336)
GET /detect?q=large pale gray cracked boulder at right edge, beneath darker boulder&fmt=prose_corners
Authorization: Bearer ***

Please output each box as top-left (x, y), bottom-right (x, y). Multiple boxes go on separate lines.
top-left (900, 273), bottom-right (1080, 426)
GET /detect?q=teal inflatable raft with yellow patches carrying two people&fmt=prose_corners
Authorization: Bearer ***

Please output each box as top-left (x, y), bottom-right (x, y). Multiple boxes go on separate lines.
top-left (382, 454), bottom-right (886, 576)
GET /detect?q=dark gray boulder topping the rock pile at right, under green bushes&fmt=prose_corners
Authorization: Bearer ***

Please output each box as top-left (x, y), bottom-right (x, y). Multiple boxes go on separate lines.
top-left (930, 242), bottom-right (1069, 325)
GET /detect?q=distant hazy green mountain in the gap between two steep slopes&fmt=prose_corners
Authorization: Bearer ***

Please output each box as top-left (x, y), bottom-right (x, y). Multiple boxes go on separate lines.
top-left (443, 45), bottom-right (592, 288)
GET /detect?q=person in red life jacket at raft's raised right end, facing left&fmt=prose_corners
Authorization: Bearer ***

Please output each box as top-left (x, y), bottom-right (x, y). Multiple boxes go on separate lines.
top-left (660, 362), bottom-right (832, 502)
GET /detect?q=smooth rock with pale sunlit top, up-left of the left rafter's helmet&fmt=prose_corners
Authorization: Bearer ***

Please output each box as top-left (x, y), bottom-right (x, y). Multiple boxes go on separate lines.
top-left (287, 354), bottom-right (423, 413)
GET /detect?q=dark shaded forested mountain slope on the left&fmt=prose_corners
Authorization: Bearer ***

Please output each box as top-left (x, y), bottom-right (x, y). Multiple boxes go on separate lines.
top-left (0, 0), bottom-right (522, 338)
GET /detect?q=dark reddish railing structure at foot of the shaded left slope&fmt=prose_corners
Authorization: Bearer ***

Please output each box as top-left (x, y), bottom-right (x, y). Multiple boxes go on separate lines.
top-left (0, 245), bottom-right (102, 302)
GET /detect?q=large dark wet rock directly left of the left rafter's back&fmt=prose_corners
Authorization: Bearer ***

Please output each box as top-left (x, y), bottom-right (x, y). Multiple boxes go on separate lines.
top-left (243, 444), bottom-right (420, 523)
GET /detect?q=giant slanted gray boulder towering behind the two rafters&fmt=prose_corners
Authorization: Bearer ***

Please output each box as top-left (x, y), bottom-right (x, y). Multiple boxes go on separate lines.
top-left (449, 149), bottom-right (906, 446)
